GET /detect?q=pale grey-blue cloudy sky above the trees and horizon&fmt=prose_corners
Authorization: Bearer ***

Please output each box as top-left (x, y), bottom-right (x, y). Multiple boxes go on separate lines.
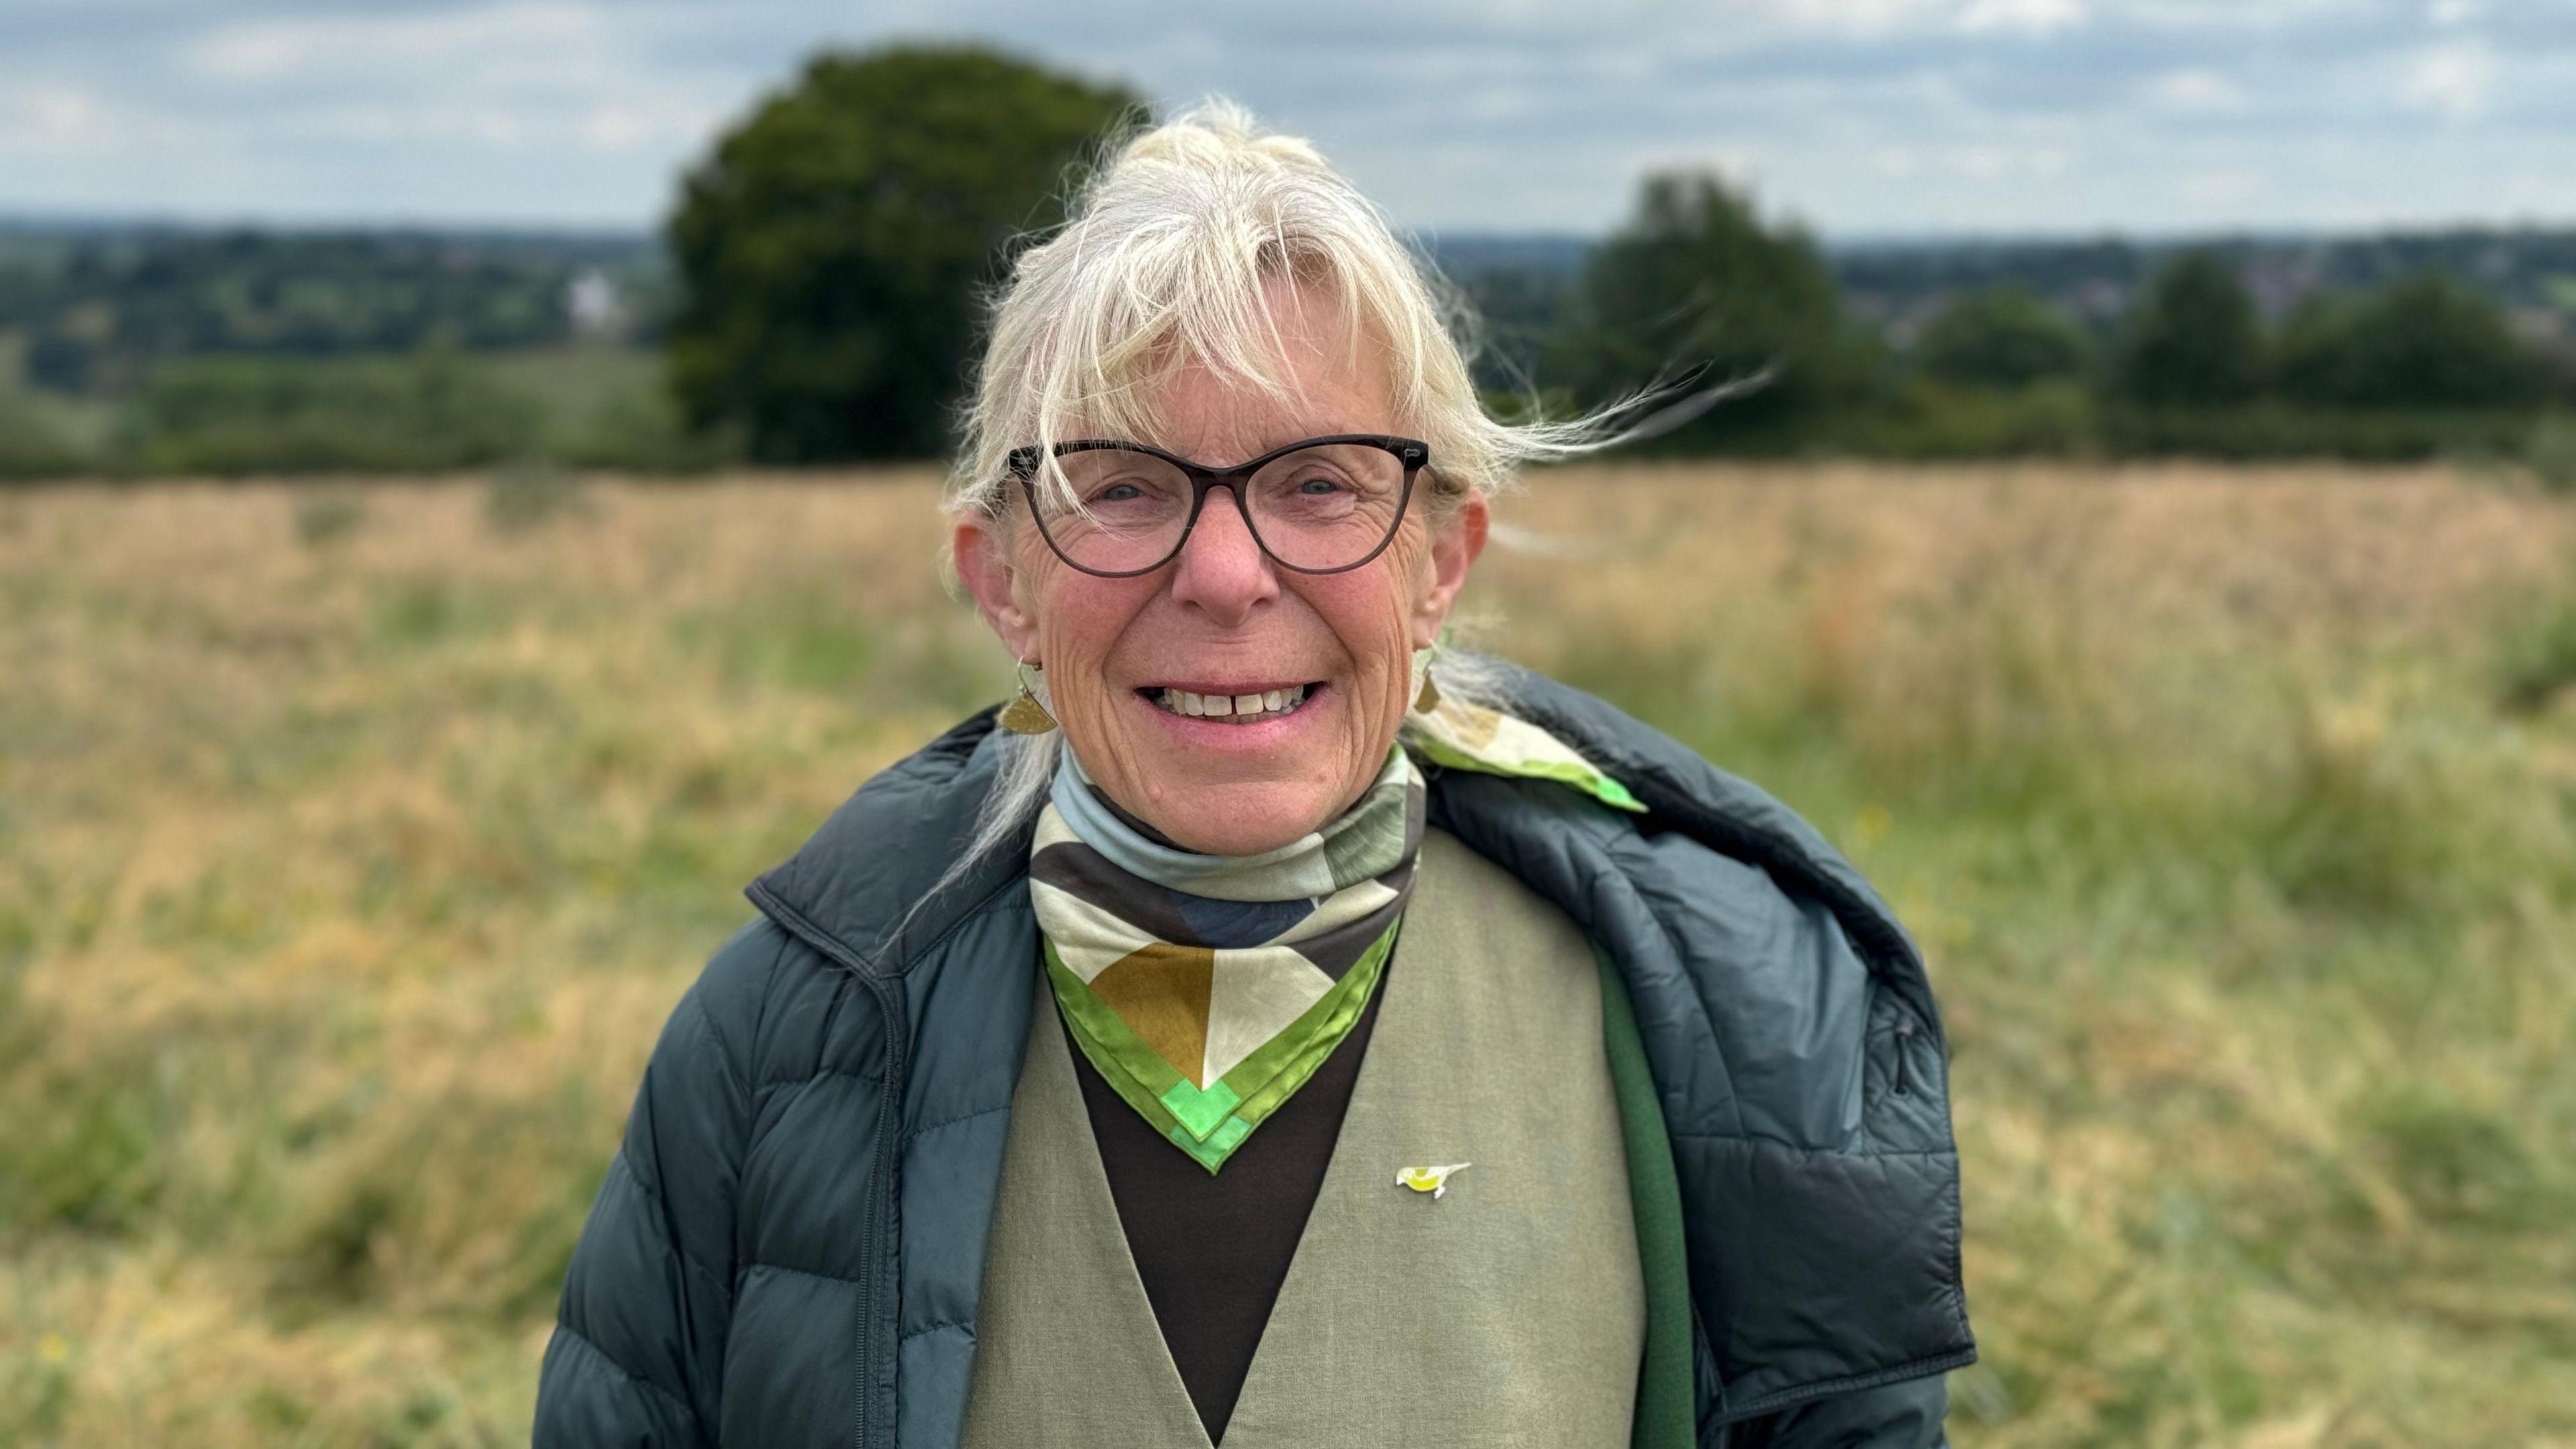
top-left (0, 0), bottom-right (2576, 237)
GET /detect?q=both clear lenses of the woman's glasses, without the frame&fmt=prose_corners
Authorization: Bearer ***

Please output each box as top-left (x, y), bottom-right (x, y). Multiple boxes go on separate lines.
top-left (1038, 443), bottom-right (1404, 572)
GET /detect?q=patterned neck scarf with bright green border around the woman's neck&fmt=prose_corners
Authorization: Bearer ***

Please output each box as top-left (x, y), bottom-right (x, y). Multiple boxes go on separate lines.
top-left (1028, 670), bottom-right (1644, 1173)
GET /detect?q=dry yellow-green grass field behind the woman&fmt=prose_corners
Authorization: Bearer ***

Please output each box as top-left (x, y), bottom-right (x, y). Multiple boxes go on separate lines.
top-left (0, 467), bottom-right (2576, 1449)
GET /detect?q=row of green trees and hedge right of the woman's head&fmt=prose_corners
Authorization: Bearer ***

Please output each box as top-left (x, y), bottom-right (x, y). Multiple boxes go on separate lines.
top-left (1468, 192), bottom-right (2576, 456)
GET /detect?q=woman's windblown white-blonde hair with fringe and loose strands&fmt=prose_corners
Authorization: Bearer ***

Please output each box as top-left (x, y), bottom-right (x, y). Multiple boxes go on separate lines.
top-left (925, 101), bottom-right (1715, 943)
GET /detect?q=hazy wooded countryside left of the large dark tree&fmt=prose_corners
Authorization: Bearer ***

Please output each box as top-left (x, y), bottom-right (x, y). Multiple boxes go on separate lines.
top-left (0, 224), bottom-right (685, 477)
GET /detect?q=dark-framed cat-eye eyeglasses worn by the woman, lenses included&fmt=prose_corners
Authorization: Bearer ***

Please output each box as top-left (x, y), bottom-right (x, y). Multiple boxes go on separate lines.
top-left (1007, 433), bottom-right (1432, 578)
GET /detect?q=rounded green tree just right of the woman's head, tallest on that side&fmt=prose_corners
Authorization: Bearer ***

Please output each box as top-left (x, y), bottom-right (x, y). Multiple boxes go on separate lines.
top-left (1543, 173), bottom-right (1870, 449)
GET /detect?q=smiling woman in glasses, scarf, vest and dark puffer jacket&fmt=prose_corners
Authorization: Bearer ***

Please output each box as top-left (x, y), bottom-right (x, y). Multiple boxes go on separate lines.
top-left (536, 106), bottom-right (1973, 1446)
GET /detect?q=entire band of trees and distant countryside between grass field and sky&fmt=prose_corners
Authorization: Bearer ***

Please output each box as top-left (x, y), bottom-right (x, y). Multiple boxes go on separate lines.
top-left (0, 46), bottom-right (2576, 474)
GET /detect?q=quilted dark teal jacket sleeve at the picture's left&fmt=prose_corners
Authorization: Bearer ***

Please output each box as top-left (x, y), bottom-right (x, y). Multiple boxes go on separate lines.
top-left (536, 920), bottom-right (786, 1449)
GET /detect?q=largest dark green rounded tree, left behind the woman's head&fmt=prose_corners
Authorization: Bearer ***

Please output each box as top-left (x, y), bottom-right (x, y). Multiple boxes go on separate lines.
top-left (669, 46), bottom-right (1141, 462)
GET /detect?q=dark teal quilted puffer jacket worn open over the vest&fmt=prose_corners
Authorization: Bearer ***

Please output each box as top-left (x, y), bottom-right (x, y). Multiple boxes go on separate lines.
top-left (536, 659), bottom-right (1976, 1449)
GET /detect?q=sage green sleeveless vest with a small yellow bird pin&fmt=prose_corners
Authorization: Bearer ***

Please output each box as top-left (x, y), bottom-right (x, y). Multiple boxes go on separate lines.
top-left (963, 830), bottom-right (1646, 1449)
